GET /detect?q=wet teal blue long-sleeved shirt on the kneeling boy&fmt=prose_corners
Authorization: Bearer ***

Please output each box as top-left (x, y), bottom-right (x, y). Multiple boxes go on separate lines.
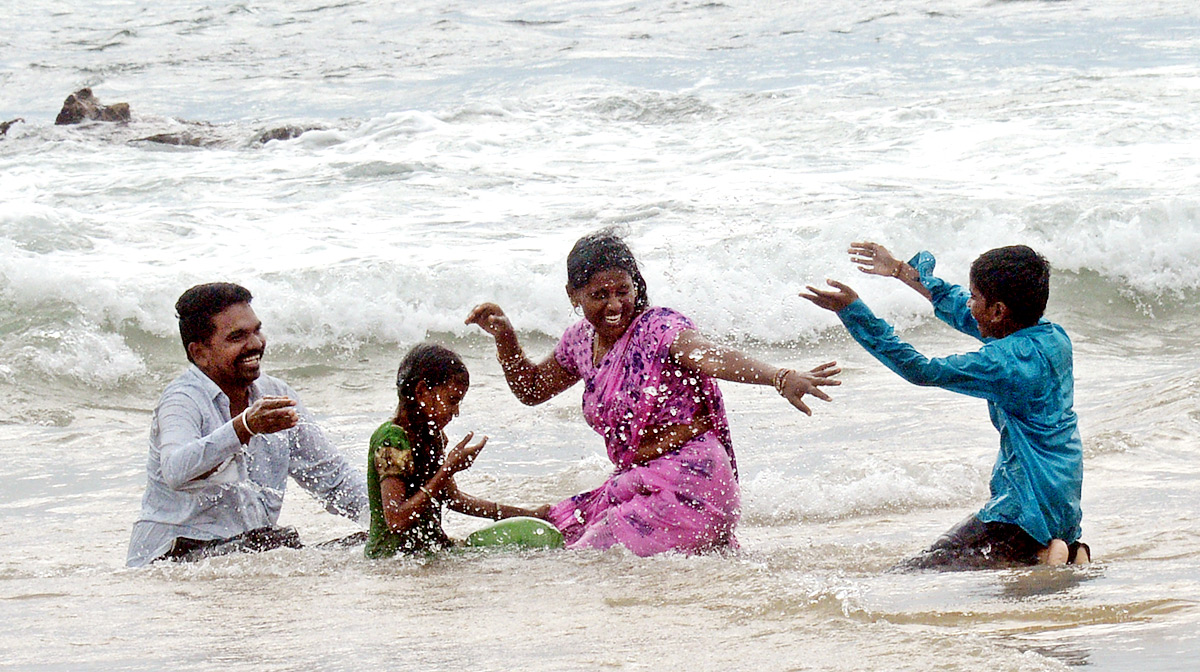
top-left (838, 252), bottom-right (1084, 544)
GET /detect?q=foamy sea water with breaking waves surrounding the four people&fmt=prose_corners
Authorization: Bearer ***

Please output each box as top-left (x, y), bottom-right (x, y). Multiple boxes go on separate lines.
top-left (0, 0), bottom-right (1200, 671)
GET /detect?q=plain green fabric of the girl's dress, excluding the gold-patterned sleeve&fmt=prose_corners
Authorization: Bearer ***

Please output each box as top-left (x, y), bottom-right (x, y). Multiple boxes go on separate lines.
top-left (364, 420), bottom-right (451, 558)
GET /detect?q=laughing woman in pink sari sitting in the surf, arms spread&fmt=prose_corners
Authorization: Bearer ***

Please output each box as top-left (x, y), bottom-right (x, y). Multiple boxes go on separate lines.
top-left (467, 232), bottom-right (839, 556)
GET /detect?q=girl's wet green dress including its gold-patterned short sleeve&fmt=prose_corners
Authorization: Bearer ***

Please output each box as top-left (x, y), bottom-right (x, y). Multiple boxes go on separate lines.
top-left (364, 421), bottom-right (454, 558)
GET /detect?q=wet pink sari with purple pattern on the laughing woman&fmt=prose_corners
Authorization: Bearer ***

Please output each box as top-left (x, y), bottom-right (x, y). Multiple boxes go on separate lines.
top-left (548, 307), bottom-right (740, 556)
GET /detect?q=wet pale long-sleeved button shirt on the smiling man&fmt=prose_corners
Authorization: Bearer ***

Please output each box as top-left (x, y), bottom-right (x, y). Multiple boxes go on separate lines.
top-left (126, 365), bottom-right (367, 566)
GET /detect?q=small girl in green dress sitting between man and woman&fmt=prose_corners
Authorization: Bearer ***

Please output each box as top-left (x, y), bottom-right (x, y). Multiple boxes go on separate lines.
top-left (366, 343), bottom-right (562, 558)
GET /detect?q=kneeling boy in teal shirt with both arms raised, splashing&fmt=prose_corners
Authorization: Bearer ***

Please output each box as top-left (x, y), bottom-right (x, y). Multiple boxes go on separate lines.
top-left (800, 242), bottom-right (1091, 569)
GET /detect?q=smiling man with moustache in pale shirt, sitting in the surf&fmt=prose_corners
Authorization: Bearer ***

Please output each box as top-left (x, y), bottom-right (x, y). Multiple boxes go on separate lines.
top-left (126, 282), bottom-right (368, 566)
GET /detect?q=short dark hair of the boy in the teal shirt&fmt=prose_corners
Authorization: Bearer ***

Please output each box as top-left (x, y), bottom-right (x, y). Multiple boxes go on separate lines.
top-left (971, 245), bottom-right (1050, 328)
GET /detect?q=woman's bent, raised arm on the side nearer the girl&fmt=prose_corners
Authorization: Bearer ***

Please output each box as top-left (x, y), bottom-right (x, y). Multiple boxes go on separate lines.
top-left (466, 304), bottom-right (578, 406)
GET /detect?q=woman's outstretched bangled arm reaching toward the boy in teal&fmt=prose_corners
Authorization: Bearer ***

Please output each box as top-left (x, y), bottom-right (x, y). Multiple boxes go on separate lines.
top-left (671, 329), bottom-right (841, 415)
